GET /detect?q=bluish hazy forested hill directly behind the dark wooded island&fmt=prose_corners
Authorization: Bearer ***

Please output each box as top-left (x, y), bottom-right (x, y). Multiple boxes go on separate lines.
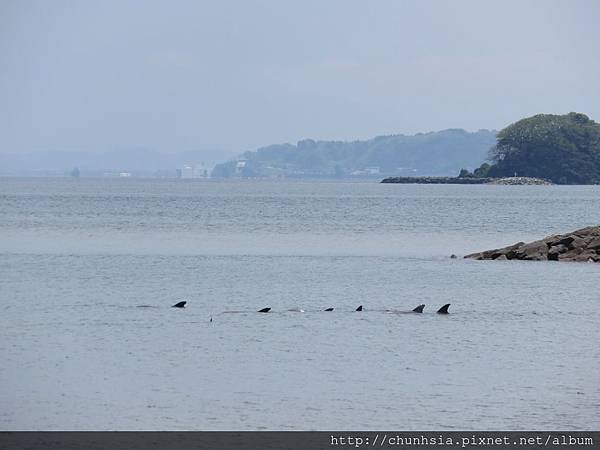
top-left (213, 129), bottom-right (496, 178)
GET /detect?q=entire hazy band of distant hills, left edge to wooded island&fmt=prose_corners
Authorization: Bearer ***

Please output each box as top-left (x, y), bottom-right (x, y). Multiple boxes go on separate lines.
top-left (0, 129), bottom-right (496, 178)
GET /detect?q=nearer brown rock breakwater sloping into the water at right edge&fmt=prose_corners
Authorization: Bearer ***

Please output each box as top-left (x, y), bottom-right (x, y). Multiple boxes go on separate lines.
top-left (465, 226), bottom-right (600, 262)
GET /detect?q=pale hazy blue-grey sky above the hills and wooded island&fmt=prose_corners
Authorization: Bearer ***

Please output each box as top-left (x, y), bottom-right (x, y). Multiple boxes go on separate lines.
top-left (0, 0), bottom-right (600, 153)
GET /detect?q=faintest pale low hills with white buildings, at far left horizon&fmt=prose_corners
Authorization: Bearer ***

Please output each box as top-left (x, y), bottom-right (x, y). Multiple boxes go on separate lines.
top-left (0, 149), bottom-right (234, 176)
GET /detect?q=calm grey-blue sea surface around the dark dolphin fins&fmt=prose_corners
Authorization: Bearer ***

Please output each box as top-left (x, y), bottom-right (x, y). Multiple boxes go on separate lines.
top-left (0, 179), bottom-right (600, 430)
